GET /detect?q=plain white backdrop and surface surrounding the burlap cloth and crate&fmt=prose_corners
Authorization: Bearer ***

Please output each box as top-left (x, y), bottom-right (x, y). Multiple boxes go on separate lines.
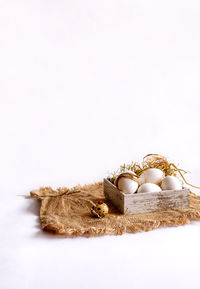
top-left (0, 0), bottom-right (200, 289)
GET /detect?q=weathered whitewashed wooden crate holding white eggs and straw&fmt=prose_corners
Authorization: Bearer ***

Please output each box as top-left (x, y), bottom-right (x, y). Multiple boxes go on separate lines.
top-left (104, 179), bottom-right (190, 214)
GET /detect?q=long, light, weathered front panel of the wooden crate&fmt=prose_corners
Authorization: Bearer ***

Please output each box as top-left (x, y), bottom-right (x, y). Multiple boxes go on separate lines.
top-left (124, 189), bottom-right (190, 214)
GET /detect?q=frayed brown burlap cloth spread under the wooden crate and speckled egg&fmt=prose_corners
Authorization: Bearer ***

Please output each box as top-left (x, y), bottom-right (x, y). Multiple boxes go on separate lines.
top-left (31, 183), bottom-right (200, 237)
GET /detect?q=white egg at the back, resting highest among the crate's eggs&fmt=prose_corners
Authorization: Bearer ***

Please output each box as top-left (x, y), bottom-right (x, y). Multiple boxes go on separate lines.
top-left (139, 168), bottom-right (164, 185)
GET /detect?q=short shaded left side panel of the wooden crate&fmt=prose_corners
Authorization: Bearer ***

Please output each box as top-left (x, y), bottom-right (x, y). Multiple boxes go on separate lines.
top-left (104, 179), bottom-right (124, 214)
